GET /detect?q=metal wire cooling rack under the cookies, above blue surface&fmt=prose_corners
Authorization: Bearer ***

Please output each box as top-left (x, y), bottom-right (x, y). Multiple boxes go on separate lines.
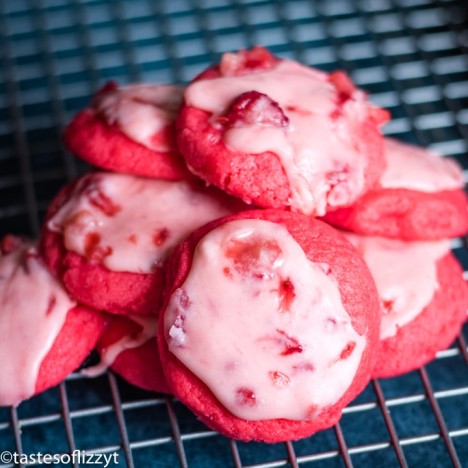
top-left (0, 0), bottom-right (468, 468)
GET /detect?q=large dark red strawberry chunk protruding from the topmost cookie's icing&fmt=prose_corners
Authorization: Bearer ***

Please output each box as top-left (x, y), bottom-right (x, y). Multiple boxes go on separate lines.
top-left (218, 91), bottom-right (289, 128)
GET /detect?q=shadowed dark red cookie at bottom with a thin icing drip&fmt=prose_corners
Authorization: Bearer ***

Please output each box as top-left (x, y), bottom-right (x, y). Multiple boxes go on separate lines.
top-left (83, 316), bottom-right (170, 393)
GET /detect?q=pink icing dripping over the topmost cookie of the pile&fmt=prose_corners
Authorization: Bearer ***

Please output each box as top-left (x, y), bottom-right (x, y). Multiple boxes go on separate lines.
top-left (185, 60), bottom-right (374, 215)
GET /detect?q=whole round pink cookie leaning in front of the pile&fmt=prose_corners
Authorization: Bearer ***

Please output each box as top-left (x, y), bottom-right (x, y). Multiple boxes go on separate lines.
top-left (158, 210), bottom-right (380, 443)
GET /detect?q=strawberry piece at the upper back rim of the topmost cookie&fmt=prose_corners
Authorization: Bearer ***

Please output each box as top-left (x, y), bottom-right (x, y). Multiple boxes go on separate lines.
top-left (219, 47), bottom-right (279, 76)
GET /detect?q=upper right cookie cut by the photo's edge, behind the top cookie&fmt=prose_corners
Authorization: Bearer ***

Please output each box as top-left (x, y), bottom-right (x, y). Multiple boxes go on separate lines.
top-left (324, 138), bottom-right (468, 241)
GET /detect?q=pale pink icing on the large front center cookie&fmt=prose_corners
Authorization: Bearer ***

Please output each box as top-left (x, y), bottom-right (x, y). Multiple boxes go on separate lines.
top-left (164, 220), bottom-right (366, 420)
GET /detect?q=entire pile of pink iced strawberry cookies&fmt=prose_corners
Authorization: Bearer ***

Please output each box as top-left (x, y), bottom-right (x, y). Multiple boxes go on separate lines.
top-left (0, 47), bottom-right (468, 442)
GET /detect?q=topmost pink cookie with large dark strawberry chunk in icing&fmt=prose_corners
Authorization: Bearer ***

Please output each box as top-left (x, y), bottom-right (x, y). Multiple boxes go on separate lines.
top-left (177, 47), bottom-right (388, 215)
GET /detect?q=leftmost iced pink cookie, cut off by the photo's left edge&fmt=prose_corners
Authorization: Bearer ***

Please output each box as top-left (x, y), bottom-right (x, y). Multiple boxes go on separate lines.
top-left (0, 236), bottom-right (106, 406)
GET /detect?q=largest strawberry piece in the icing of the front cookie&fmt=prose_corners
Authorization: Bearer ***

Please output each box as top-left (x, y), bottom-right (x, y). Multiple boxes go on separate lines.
top-left (224, 238), bottom-right (282, 280)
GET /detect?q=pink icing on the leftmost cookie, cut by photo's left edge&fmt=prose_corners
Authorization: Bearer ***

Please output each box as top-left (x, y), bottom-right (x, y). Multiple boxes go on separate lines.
top-left (0, 238), bottom-right (76, 405)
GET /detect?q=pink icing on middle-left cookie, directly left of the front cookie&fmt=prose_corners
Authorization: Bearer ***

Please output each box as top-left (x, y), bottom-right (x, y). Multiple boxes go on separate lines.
top-left (48, 173), bottom-right (234, 273)
